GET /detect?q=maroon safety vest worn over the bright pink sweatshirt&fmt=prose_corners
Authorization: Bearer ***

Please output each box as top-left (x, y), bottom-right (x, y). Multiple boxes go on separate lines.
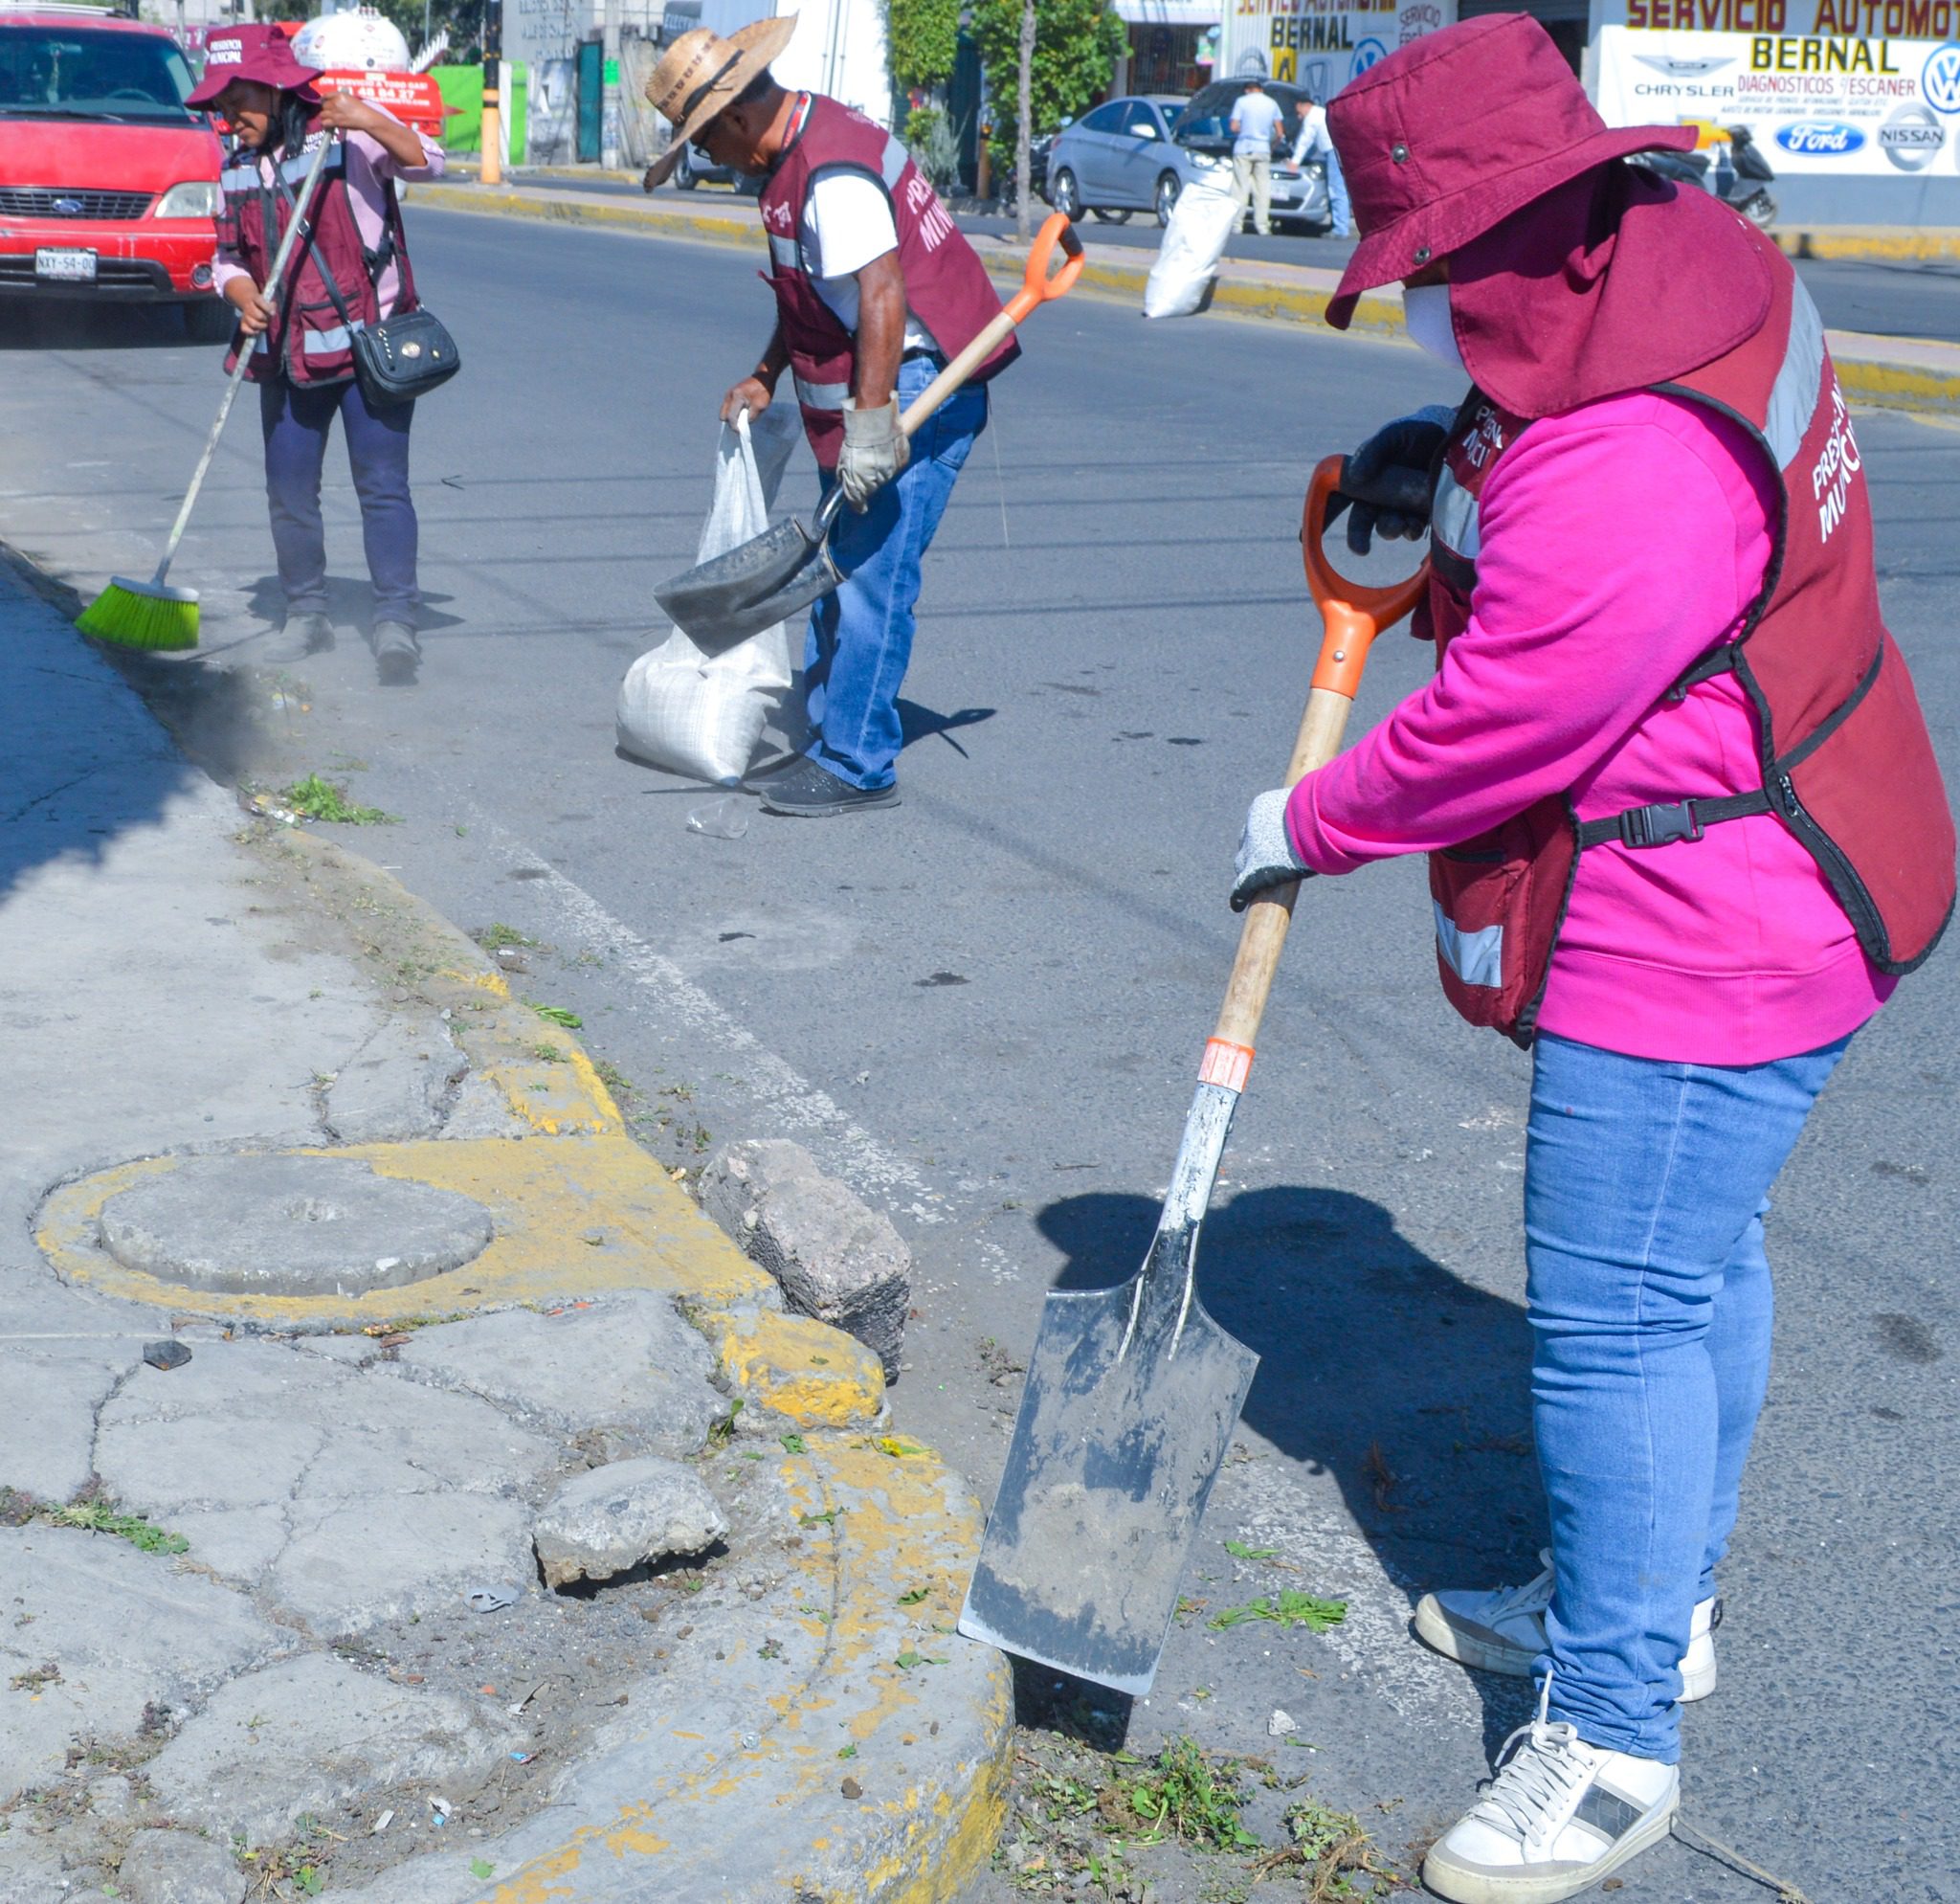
top-left (1429, 235), bottom-right (1954, 1045)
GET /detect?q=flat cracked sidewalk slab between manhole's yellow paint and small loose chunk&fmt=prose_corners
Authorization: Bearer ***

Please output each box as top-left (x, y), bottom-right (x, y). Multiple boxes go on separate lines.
top-left (400, 1290), bottom-right (729, 1455)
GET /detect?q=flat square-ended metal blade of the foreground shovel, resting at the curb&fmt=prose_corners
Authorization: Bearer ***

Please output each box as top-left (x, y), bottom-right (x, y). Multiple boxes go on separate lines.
top-left (961, 1214), bottom-right (1258, 1694)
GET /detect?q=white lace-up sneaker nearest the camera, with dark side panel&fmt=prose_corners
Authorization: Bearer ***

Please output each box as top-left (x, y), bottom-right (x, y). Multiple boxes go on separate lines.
top-left (1423, 1678), bottom-right (1682, 1904)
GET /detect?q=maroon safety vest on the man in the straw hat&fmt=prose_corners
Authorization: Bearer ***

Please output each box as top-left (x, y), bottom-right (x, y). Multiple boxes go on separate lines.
top-left (763, 92), bottom-right (1021, 469)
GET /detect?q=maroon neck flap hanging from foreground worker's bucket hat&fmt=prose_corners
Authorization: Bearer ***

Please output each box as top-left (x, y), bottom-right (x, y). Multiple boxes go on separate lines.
top-left (1451, 161), bottom-right (1771, 417)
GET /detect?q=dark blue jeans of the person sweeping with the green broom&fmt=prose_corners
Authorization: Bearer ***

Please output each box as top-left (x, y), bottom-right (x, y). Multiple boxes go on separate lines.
top-left (258, 376), bottom-right (421, 625)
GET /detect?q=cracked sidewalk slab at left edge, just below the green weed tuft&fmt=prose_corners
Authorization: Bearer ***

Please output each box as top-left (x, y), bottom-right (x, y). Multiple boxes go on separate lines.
top-left (0, 1524), bottom-right (280, 1804)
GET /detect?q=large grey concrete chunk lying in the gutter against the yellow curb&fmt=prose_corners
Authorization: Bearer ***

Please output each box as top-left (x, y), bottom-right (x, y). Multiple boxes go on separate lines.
top-left (700, 1137), bottom-right (911, 1380)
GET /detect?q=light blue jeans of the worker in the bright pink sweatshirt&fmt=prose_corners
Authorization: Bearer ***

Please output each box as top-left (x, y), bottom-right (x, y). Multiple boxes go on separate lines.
top-left (1525, 1038), bottom-right (1850, 1765)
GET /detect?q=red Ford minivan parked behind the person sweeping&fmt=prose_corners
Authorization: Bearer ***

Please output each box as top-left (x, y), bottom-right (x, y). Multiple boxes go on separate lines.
top-left (0, 0), bottom-right (232, 337)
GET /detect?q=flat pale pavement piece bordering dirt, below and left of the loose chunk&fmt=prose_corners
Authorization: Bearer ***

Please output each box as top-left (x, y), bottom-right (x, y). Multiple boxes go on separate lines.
top-left (147, 1653), bottom-right (520, 1846)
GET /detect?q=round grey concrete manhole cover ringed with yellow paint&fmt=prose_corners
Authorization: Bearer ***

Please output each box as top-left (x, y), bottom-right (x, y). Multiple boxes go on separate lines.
top-left (100, 1157), bottom-right (494, 1296)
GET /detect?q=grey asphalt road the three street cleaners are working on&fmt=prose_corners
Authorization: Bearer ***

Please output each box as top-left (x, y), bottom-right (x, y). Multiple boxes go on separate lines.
top-left (0, 200), bottom-right (1960, 1904)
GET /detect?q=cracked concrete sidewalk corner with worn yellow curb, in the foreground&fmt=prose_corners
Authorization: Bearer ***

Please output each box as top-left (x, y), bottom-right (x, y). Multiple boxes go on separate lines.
top-left (0, 565), bottom-right (1010, 1904)
